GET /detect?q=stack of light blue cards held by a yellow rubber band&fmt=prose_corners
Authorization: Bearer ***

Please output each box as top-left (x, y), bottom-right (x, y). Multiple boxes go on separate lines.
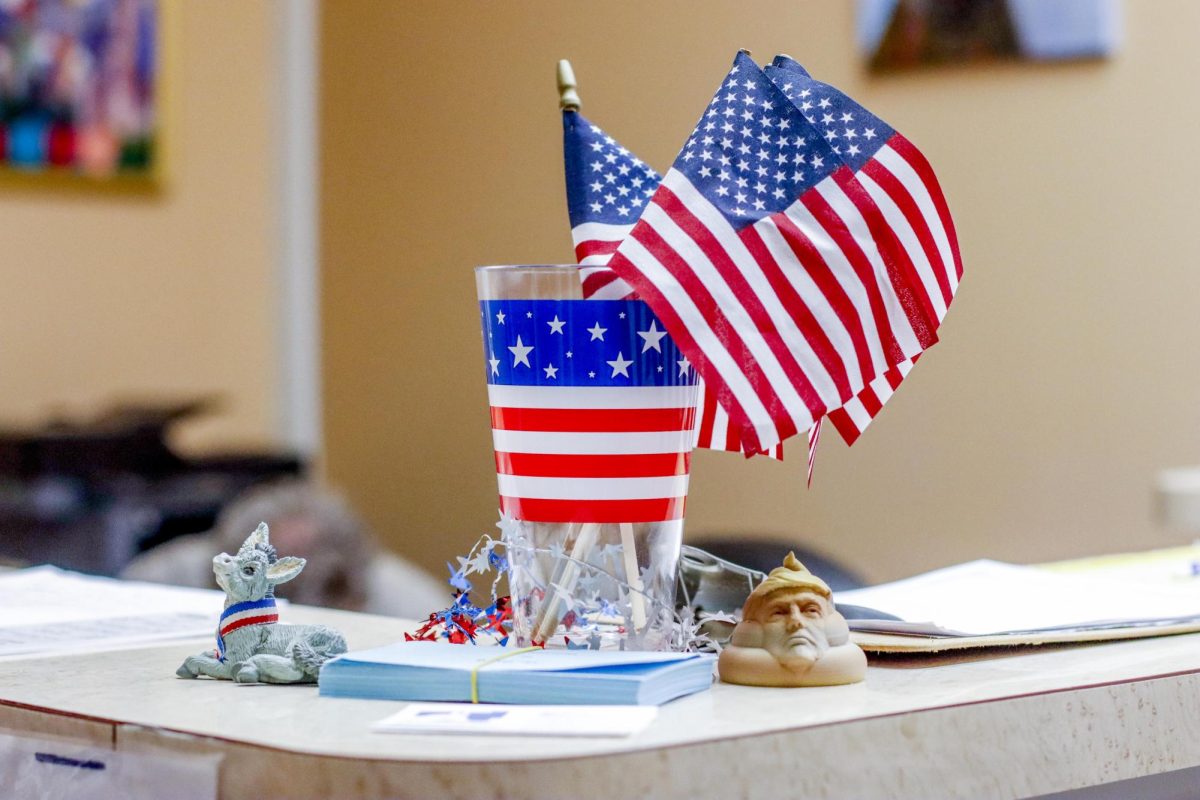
top-left (320, 642), bottom-right (713, 705)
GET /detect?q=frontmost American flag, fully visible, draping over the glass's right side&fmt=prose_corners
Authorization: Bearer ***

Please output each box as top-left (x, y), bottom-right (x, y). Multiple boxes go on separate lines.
top-left (610, 53), bottom-right (937, 452)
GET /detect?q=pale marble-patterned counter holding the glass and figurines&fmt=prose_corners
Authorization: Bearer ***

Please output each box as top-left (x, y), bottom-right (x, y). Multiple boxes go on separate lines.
top-left (0, 607), bottom-right (1200, 800)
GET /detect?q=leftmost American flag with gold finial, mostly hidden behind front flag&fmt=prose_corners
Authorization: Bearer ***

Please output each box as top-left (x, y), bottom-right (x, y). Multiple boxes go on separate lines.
top-left (563, 110), bottom-right (792, 462)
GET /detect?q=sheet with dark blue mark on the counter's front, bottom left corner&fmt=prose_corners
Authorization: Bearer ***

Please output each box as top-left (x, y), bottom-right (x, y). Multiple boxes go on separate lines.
top-left (0, 734), bottom-right (221, 800)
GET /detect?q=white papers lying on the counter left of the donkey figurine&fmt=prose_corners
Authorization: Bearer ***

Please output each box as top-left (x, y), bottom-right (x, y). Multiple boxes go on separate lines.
top-left (0, 566), bottom-right (224, 656)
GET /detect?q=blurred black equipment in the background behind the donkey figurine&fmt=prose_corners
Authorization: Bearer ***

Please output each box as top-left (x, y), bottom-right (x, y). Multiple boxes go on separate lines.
top-left (0, 401), bottom-right (306, 575)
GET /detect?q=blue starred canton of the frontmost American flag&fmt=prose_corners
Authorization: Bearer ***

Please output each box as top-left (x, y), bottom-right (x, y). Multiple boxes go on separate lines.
top-left (674, 54), bottom-right (842, 227)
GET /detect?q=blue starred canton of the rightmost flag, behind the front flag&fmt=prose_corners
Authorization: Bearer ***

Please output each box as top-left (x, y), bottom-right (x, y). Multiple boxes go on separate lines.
top-left (766, 55), bottom-right (895, 173)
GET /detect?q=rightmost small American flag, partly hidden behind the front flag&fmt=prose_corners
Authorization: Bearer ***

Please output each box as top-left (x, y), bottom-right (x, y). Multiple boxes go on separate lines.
top-left (764, 55), bottom-right (962, 445)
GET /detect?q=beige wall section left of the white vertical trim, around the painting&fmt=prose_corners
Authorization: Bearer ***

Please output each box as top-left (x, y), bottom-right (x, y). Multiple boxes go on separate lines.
top-left (0, 0), bottom-right (278, 447)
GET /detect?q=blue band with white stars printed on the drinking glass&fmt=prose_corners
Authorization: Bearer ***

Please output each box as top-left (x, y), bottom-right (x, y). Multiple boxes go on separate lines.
top-left (479, 300), bottom-right (696, 386)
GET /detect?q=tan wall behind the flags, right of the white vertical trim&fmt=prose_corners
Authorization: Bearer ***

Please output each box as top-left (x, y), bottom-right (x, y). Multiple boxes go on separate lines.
top-left (320, 0), bottom-right (1200, 578)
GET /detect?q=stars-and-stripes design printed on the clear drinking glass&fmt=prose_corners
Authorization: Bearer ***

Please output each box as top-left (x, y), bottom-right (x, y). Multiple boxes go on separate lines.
top-left (480, 300), bottom-right (696, 523)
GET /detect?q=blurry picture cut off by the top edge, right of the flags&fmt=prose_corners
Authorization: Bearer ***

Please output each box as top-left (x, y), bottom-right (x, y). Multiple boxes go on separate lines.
top-left (858, 0), bottom-right (1121, 72)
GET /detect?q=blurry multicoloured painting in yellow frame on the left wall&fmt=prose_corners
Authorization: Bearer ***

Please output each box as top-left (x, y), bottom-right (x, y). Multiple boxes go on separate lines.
top-left (0, 0), bottom-right (162, 185)
